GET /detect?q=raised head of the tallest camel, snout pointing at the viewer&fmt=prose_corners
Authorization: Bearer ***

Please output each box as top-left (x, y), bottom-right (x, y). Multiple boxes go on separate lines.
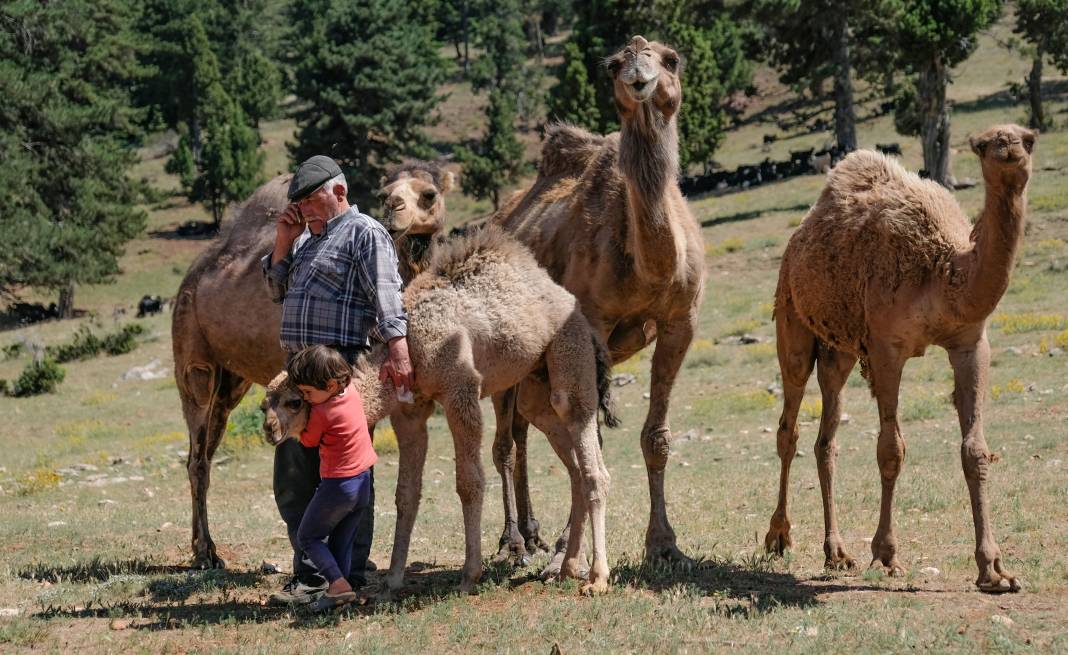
top-left (604, 36), bottom-right (682, 121)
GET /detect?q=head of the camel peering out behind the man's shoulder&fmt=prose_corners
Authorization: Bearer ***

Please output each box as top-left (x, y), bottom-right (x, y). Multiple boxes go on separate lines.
top-left (378, 161), bottom-right (454, 239)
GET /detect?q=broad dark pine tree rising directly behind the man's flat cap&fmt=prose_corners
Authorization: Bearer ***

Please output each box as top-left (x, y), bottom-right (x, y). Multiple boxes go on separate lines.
top-left (289, 0), bottom-right (444, 200)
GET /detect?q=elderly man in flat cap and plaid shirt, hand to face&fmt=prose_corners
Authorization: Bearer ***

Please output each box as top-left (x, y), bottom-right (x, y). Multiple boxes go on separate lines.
top-left (263, 155), bottom-right (415, 604)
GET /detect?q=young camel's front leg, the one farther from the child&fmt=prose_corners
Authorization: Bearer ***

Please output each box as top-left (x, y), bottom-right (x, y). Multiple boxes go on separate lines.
top-left (444, 378), bottom-right (485, 593)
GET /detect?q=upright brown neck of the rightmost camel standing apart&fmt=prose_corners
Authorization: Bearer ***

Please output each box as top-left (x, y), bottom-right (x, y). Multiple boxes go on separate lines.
top-left (960, 181), bottom-right (1026, 322)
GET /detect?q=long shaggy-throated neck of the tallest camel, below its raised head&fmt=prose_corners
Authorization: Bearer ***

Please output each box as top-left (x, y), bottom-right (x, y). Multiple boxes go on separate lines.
top-left (619, 105), bottom-right (686, 280)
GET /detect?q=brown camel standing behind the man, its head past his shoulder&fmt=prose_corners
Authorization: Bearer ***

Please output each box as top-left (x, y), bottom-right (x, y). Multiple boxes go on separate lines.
top-left (171, 165), bottom-right (451, 568)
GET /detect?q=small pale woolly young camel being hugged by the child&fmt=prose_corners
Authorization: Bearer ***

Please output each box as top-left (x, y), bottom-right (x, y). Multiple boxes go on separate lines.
top-left (264, 228), bottom-right (614, 593)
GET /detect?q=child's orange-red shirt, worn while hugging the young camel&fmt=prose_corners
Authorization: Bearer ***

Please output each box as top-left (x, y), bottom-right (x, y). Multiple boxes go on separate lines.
top-left (300, 384), bottom-right (378, 478)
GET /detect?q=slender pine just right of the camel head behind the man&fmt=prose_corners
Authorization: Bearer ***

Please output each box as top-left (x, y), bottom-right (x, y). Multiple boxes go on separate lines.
top-left (456, 0), bottom-right (525, 209)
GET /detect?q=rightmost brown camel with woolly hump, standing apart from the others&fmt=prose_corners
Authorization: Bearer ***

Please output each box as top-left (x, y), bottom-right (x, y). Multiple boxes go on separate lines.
top-left (765, 125), bottom-right (1036, 592)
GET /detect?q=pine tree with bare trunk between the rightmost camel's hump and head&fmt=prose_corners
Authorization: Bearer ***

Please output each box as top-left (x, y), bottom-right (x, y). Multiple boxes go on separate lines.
top-left (895, 0), bottom-right (1001, 186)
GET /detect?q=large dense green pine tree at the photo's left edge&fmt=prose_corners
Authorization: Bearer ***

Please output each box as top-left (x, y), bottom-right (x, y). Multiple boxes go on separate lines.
top-left (0, 0), bottom-right (145, 316)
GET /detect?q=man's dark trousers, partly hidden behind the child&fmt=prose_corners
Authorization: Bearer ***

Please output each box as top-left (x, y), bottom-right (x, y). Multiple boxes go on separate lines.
top-left (274, 344), bottom-right (375, 589)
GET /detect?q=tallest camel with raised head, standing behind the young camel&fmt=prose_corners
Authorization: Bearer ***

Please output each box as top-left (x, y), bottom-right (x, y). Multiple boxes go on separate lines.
top-left (493, 36), bottom-right (704, 564)
